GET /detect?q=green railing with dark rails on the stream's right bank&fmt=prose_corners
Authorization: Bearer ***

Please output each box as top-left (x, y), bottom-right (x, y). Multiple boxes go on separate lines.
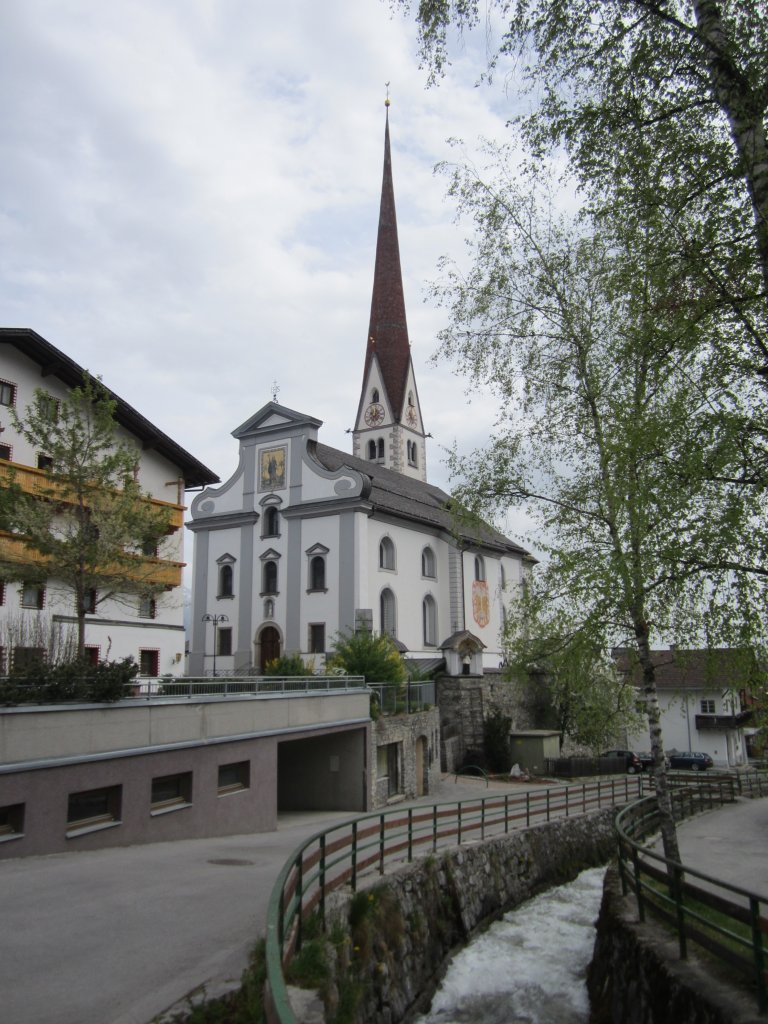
top-left (615, 774), bottom-right (768, 1013)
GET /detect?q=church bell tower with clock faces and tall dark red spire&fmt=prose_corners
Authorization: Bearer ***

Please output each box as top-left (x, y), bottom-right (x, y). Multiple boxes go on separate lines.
top-left (352, 96), bottom-right (427, 481)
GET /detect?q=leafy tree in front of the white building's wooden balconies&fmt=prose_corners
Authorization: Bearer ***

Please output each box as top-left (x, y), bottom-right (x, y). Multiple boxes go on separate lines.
top-left (0, 375), bottom-right (169, 654)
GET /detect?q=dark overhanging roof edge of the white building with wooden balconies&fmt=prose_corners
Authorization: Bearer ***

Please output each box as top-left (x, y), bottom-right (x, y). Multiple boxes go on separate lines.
top-left (0, 327), bottom-right (219, 487)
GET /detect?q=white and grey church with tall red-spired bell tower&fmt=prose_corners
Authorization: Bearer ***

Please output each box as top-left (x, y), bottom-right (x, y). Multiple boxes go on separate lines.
top-left (187, 104), bottom-right (536, 676)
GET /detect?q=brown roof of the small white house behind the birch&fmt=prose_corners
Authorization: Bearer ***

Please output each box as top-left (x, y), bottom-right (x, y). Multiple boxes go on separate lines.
top-left (612, 647), bottom-right (757, 690)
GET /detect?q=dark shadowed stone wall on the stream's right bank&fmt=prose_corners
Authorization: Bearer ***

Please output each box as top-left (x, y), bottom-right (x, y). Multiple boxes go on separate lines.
top-left (588, 866), bottom-right (766, 1024)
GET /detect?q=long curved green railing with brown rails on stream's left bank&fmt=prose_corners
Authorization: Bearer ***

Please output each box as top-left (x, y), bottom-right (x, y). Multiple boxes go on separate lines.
top-left (266, 775), bottom-right (648, 1024)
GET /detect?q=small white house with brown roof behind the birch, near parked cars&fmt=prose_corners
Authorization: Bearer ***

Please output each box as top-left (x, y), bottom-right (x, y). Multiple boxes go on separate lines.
top-left (614, 647), bottom-right (755, 767)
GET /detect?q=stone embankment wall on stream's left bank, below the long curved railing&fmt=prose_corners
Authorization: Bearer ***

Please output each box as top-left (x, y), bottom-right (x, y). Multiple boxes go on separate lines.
top-left (305, 809), bottom-right (614, 1024)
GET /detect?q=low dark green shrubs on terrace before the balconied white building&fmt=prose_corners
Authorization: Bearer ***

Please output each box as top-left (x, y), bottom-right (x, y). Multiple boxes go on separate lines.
top-left (0, 657), bottom-right (138, 703)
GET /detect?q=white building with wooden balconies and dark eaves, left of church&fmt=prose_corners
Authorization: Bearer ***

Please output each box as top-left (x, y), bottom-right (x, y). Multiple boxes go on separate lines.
top-left (0, 328), bottom-right (218, 676)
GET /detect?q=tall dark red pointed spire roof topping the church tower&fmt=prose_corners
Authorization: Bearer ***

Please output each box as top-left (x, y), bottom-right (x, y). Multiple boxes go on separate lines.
top-left (364, 105), bottom-right (411, 419)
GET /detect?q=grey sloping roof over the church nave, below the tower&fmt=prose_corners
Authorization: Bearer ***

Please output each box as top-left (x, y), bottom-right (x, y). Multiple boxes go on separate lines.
top-left (308, 442), bottom-right (536, 562)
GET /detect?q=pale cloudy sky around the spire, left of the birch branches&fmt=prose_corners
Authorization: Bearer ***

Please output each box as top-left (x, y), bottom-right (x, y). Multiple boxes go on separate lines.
top-left (0, 0), bottom-right (536, 534)
